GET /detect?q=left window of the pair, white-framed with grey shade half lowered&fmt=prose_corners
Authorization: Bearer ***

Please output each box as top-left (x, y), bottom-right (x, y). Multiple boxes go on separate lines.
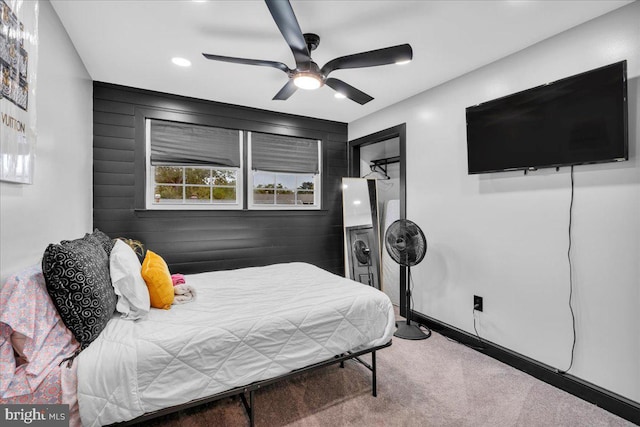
top-left (146, 120), bottom-right (242, 209)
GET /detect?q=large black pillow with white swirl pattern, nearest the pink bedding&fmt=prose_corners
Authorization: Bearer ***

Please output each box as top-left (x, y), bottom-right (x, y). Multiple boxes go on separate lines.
top-left (42, 235), bottom-right (117, 349)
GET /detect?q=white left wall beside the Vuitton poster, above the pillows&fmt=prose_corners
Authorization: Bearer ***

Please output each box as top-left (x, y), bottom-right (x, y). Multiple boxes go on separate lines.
top-left (0, 1), bottom-right (93, 283)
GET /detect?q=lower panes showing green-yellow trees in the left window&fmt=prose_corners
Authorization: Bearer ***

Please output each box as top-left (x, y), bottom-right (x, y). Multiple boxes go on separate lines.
top-left (154, 166), bottom-right (238, 204)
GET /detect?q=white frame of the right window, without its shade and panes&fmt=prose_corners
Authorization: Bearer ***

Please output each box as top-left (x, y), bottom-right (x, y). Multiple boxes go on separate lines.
top-left (246, 131), bottom-right (323, 211)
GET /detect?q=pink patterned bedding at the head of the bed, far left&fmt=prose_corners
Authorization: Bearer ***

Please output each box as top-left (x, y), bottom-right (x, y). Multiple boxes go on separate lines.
top-left (0, 266), bottom-right (79, 425)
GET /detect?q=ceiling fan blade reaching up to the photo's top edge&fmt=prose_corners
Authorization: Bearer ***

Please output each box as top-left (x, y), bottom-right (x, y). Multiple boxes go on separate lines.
top-left (265, 0), bottom-right (311, 70)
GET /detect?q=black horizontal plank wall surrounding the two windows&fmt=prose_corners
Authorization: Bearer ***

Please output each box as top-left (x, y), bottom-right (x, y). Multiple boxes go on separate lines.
top-left (93, 82), bottom-right (348, 275)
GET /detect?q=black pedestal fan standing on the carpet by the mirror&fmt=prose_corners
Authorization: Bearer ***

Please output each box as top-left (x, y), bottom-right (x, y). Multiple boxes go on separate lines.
top-left (384, 219), bottom-right (431, 340)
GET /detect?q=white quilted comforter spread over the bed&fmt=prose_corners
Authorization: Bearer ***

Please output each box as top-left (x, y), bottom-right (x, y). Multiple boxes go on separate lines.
top-left (75, 263), bottom-right (395, 427)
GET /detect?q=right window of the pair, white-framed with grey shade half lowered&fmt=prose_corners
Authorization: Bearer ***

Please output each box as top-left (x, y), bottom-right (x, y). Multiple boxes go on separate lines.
top-left (248, 132), bottom-right (321, 209)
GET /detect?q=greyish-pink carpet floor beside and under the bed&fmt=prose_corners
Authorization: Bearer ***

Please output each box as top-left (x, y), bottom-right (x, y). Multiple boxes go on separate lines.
top-left (136, 326), bottom-right (635, 427)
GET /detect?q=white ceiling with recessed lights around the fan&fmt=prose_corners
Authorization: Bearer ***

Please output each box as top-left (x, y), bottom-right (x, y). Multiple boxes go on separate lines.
top-left (51, 0), bottom-right (631, 123)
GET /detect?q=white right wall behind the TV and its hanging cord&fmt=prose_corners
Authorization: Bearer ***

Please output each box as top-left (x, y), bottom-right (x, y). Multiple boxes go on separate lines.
top-left (349, 2), bottom-right (640, 402)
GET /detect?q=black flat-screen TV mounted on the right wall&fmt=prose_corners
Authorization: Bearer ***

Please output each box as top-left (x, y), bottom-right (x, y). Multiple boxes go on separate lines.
top-left (466, 61), bottom-right (629, 174)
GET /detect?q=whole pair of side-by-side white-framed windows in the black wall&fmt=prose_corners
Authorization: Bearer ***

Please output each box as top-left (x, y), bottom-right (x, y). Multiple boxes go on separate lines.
top-left (145, 119), bottom-right (322, 210)
